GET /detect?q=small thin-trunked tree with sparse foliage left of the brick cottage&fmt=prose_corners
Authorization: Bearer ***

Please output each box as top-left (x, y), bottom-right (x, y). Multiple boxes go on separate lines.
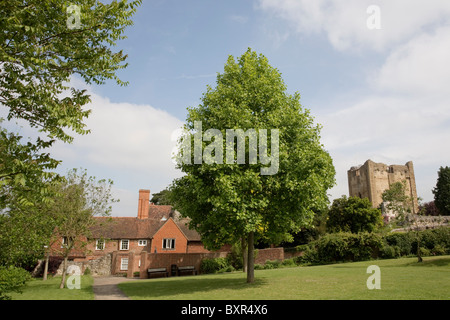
top-left (48, 169), bottom-right (117, 288)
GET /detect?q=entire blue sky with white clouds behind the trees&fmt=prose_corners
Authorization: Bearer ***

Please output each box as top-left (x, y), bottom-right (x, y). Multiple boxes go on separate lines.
top-left (45, 0), bottom-right (450, 216)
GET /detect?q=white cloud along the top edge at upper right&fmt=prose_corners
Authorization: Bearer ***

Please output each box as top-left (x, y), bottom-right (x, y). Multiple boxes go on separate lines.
top-left (259, 0), bottom-right (450, 51)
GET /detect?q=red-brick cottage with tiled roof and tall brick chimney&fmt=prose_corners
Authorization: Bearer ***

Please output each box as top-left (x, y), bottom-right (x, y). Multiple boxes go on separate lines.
top-left (51, 190), bottom-right (230, 277)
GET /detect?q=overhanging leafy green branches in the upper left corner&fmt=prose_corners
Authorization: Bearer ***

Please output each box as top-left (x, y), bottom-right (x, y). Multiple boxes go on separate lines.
top-left (0, 0), bottom-right (141, 205)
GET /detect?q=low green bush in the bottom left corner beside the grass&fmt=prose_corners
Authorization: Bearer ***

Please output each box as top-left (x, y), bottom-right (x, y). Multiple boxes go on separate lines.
top-left (0, 266), bottom-right (31, 300)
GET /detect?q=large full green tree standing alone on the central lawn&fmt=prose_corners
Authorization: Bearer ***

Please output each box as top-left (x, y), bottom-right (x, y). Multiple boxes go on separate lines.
top-left (170, 49), bottom-right (335, 282)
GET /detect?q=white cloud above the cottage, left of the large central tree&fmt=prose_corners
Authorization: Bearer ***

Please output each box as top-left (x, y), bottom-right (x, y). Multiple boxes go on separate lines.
top-left (50, 92), bottom-right (183, 216)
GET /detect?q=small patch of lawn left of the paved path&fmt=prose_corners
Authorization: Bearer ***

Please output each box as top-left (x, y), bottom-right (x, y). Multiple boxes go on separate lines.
top-left (11, 276), bottom-right (94, 300)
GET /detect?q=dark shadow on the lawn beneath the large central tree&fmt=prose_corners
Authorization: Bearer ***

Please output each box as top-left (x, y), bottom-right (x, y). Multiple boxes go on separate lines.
top-left (119, 275), bottom-right (267, 299)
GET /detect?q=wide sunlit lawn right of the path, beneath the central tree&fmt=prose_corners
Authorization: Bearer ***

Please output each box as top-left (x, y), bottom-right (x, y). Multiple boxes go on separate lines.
top-left (119, 256), bottom-right (450, 300)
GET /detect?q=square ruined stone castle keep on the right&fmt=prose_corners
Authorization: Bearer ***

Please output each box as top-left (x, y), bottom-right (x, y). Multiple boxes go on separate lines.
top-left (347, 160), bottom-right (419, 213)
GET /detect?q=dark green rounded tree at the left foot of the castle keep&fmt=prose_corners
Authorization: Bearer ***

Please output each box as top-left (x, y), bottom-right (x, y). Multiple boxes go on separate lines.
top-left (327, 196), bottom-right (383, 233)
